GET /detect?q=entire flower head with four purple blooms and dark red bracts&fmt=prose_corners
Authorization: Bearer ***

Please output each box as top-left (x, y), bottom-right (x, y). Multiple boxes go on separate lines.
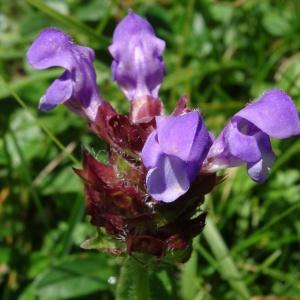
top-left (27, 11), bottom-right (300, 261)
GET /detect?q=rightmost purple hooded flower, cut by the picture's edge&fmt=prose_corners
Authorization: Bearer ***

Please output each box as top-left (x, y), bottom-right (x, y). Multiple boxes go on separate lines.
top-left (204, 89), bottom-right (300, 182)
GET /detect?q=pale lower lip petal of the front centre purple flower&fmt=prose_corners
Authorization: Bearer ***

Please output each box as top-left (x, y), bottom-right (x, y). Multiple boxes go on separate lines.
top-left (146, 155), bottom-right (190, 203)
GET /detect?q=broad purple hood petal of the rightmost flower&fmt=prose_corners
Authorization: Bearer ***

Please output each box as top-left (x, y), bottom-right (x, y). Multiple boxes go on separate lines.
top-left (236, 89), bottom-right (300, 139)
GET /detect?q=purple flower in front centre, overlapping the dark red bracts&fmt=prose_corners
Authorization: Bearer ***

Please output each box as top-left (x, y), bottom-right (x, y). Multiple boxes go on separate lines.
top-left (141, 111), bottom-right (211, 202)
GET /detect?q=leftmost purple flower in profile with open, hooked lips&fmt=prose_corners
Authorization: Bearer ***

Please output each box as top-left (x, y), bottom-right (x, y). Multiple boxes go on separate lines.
top-left (27, 28), bottom-right (101, 120)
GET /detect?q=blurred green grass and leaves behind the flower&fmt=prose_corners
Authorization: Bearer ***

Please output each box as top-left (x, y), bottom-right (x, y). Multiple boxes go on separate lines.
top-left (0, 0), bottom-right (300, 300)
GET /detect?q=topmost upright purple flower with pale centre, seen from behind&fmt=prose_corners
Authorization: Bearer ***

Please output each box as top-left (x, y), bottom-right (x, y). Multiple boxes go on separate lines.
top-left (109, 11), bottom-right (165, 100)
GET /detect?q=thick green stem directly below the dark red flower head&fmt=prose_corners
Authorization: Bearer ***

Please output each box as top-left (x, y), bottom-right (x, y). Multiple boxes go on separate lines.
top-left (116, 256), bottom-right (151, 300)
